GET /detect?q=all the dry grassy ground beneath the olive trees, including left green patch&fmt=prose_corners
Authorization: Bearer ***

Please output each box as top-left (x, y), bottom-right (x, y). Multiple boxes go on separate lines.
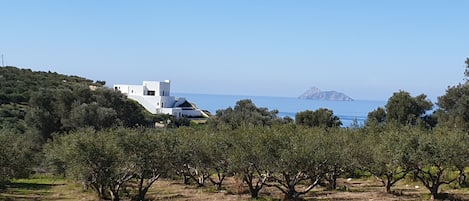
top-left (0, 178), bottom-right (469, 201)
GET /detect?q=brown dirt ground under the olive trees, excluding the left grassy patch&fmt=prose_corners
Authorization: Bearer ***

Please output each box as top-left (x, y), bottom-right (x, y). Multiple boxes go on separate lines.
top-left (144, 178), bottom-right (469, 201)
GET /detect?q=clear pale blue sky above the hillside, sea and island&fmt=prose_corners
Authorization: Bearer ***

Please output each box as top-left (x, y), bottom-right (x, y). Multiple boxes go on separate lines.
top-left (0, 0), bottom-right (469, 100)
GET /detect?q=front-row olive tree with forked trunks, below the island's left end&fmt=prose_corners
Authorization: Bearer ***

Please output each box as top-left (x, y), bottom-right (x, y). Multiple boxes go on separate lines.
top-left (268, 126), bottom-right (327, 200)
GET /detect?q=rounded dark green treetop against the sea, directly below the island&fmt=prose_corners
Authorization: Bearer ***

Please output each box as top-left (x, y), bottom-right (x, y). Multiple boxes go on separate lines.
top-left (295, 108), bottom-right (342, 128)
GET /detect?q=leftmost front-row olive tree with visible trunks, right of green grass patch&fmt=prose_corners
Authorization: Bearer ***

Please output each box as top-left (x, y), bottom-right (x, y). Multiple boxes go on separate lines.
top-left (44, 129), bottom-right (133, 200)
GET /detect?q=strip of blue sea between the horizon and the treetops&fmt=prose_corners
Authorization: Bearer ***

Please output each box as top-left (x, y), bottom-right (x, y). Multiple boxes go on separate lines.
top-left (172, 93), bottom-right (386, 127)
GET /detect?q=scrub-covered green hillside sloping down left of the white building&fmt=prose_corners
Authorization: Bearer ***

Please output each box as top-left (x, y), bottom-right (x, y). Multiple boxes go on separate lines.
top-left (0, 66), bottom-right (152, 135)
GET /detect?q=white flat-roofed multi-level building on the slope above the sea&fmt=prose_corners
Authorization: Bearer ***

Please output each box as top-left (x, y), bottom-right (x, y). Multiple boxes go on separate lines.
top-left (114, 80), bottom-right (203, 118)
